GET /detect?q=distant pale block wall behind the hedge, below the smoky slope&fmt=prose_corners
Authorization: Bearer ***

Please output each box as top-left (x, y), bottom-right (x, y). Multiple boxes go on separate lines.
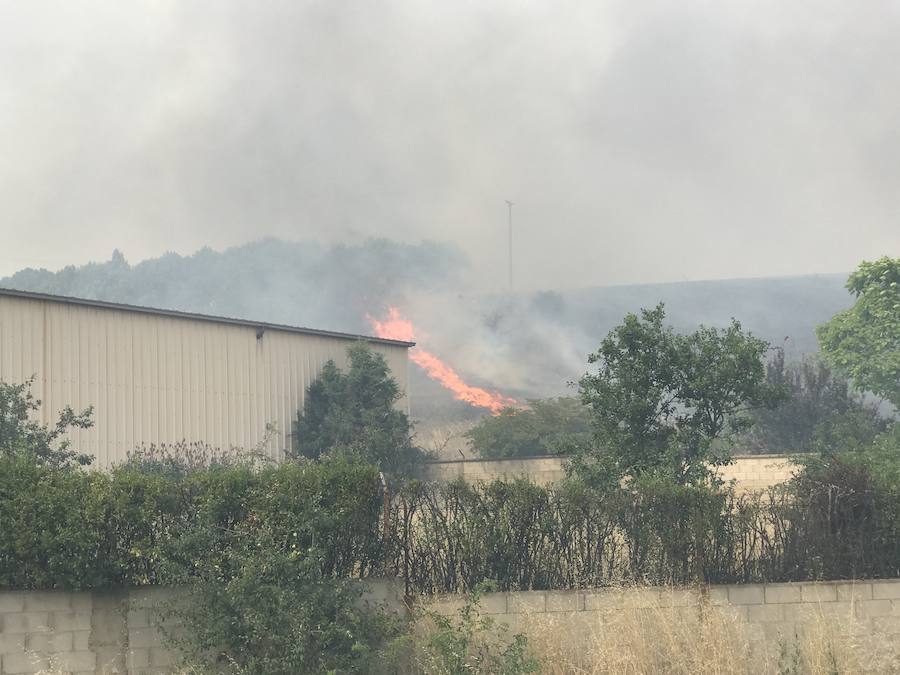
top-left (423, 455), bottom-right (796, 492)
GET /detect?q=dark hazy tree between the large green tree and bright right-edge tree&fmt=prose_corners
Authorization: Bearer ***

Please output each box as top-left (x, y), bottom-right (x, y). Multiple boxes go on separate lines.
top-left (736, 350), bottom-right (889, 453)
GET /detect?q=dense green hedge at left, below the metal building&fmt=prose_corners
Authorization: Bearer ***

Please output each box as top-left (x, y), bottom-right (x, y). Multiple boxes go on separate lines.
top-left (0, 458), bottom-right (385, 589)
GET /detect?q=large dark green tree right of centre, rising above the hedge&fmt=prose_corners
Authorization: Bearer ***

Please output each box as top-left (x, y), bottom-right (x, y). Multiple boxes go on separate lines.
top-left (573, 304), bottom-right (784, 484)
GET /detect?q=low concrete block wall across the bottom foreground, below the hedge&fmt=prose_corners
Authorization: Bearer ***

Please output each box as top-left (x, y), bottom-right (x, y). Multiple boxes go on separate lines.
top-left (0, 579), bottom-right (900, 675)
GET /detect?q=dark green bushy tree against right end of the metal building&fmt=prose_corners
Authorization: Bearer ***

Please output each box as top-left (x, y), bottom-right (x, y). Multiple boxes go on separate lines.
top-left (293, 343), bottom-right (420, 476)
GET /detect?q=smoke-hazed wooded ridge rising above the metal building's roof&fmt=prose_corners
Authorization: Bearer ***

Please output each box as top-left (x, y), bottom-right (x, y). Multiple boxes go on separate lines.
top-left (0, 239), bottom-right (467, 340)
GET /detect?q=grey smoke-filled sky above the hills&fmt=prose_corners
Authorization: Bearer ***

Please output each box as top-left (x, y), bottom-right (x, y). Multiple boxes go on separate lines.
top-left (0, 0), bottom-right (900, 288)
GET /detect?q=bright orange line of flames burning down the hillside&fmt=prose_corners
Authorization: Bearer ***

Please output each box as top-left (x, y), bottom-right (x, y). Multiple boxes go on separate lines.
top-left (369, 307), bottom-right (519, 415)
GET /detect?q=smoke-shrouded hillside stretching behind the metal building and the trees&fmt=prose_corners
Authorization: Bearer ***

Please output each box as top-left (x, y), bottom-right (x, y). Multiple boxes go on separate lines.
top-left (0, 239), bottom-right (851, 424)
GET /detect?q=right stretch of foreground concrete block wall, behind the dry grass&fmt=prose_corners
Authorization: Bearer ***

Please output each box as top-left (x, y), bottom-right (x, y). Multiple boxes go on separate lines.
top-left (432, 579), bottom-right (900, 672)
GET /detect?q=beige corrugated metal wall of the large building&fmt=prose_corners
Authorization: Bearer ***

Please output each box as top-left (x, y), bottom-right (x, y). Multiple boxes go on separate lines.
top-left (0, 295), bottom-right (408, 467)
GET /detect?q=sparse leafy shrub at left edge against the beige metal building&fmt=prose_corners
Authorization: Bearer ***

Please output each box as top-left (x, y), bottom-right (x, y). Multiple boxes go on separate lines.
top-left (0, 378), bottom-right (94, 466)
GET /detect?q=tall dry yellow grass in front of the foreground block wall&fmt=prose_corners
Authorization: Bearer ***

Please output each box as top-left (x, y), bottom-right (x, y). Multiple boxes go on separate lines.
top-left (516, 589), bottom-right (900, 675)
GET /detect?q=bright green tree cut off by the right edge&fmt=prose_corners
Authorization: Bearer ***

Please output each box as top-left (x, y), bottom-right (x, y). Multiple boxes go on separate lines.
top-left (816, 257), bottom-right (900, 408)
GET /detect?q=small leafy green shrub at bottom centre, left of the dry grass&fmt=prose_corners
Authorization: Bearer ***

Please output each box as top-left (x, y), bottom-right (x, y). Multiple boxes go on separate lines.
top-left (416, 582), bottom-right (540, 675)
